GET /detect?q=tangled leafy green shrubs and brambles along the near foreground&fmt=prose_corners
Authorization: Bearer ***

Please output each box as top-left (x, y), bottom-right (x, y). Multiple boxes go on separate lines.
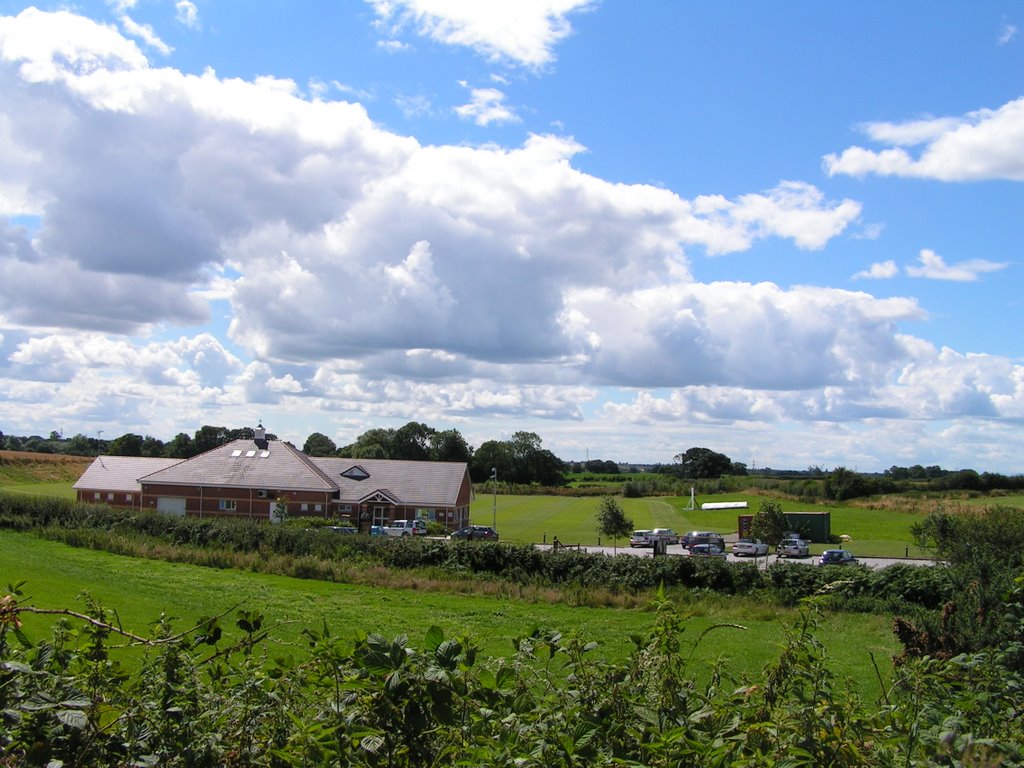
top-left (0, 586), bottom-right (1024, 768)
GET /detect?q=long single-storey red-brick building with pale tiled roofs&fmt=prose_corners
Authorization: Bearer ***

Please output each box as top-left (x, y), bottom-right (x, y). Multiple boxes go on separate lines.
top-left (75, 427), bottom-right (473, 530)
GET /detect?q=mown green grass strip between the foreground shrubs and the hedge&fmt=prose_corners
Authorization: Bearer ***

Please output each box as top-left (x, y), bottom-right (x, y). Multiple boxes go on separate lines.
top-left (0, 531), bottom-right (898, 698)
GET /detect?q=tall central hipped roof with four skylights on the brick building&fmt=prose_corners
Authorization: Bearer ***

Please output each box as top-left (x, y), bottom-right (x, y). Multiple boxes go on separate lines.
top-left (143, 440), bottom-right (337, 493)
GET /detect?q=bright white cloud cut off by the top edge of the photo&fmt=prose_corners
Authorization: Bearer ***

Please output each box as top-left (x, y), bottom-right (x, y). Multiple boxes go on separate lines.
top-left (367, 0), bottom-right (595, 68)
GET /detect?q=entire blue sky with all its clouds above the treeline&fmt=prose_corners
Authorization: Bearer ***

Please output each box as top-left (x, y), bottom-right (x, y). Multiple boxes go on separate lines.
top-left (0, 0), bottom-right (1024, 474)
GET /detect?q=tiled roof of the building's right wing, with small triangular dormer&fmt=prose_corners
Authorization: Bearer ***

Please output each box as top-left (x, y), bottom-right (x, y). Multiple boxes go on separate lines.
top-left (310, 458), bottom-right (467, 507)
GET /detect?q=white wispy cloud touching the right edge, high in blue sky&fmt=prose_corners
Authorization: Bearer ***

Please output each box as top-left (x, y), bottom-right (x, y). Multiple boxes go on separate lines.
top-left (824, 98), bottom-right (1024, 181)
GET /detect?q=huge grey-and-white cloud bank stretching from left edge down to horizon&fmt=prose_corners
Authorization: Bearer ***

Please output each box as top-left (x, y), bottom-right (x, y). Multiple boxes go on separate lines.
top-left (0, 6), bottom-right (1024, 473)
